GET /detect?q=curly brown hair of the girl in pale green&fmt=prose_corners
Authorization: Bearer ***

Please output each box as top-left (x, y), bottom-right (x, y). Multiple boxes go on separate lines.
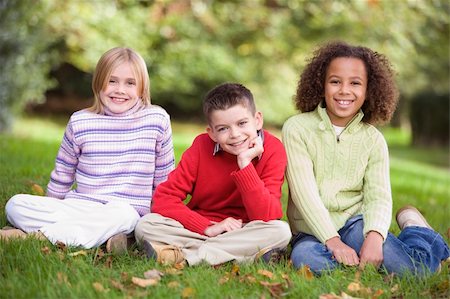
top-left (294, 41), bottom-right (399, 124)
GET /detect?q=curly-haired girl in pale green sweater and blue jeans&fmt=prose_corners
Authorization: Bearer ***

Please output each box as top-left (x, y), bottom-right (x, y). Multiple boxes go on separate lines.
top-left (282, 42), bottom-right (449, 274)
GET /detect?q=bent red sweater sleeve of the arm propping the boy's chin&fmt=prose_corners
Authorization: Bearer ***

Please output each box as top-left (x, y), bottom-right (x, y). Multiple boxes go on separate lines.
top-left (232, 136), bottom-right (286, 221)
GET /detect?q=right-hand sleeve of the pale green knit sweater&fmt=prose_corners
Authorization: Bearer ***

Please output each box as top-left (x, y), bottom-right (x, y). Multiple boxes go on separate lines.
top-left (363, 132), bottom-right (392, 240)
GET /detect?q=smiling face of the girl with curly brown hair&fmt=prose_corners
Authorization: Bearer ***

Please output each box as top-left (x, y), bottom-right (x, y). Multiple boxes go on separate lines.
top-left (325, 57), bottom-right (367, 127)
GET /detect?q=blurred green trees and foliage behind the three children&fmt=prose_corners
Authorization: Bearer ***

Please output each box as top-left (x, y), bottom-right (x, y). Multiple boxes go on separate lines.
top-left (0, 0), bottom-right (450, 145)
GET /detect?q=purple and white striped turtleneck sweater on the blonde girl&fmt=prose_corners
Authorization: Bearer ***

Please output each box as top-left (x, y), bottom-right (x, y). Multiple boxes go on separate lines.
top-left (47, 105), bottom-right (175, 216)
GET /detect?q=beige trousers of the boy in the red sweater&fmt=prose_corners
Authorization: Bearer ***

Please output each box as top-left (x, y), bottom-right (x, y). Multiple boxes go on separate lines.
top-left (135, 213), bottom-right (292, 266)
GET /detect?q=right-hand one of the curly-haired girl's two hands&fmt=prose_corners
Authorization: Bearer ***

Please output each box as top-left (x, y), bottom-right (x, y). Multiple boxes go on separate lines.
top-left (359, 231), bottom-right (383, 269)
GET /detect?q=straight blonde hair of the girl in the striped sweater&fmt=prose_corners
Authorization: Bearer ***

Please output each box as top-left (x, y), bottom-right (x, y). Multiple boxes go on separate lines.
top-left (89, 47), bottom-right (151, 113)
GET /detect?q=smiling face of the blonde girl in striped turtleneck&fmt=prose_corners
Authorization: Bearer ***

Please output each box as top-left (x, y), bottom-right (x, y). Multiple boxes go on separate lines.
top-left (100, 63), bottom-right (139, 113)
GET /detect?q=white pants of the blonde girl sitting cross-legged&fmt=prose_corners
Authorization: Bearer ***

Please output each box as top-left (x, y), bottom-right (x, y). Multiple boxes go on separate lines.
top-left (5, 194), bottom-right (139, 249)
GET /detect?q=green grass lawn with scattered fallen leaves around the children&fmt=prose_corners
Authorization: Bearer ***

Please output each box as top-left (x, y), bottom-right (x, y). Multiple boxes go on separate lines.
top-left (0, 119), bottom-right (450, 298)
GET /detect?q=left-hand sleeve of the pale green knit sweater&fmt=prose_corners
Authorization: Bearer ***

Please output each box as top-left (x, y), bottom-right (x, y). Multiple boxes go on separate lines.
top-left (282, 119), bottom-right (339, 243)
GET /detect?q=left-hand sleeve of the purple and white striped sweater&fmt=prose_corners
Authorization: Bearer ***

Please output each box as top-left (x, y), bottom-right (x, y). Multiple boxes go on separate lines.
top-left (47, 121), bottom-right (80, 199)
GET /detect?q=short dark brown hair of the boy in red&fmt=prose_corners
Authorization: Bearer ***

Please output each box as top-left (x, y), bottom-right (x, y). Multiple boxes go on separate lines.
top-left (203, 83), bottom-right (256, 122)
